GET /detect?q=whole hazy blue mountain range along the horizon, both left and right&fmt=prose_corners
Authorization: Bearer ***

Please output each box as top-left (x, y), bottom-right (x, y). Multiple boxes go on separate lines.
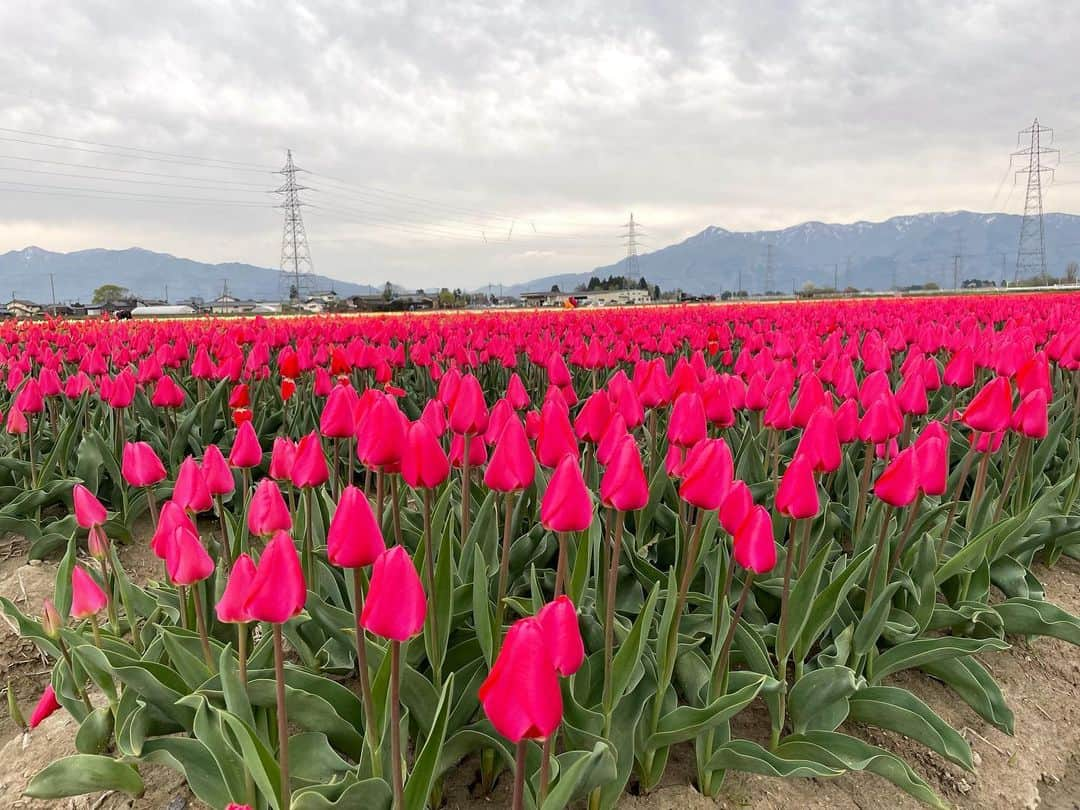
top-left (0, 211), bottom-right (1080, 302)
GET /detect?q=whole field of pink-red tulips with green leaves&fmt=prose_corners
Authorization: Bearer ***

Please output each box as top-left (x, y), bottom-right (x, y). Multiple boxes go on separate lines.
top-left (0, 294), bottom-right (1080, 810)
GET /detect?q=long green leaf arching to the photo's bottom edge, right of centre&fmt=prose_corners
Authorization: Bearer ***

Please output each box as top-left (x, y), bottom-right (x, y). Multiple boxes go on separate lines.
top-left (777, 731), bottom-right (947, 810)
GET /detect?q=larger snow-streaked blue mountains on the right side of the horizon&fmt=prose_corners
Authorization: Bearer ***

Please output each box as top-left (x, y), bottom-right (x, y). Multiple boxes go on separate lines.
top-left (510, 211), bottom-right (1080, 295)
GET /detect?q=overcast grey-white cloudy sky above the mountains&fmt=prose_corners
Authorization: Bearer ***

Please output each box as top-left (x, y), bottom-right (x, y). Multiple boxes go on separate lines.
top-left (0, 0), bottom-right (1080, 286)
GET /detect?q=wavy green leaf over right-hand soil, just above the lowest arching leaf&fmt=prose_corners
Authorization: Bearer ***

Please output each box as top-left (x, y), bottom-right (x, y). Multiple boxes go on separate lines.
top-left (848, 686), bottom-right (972, 771)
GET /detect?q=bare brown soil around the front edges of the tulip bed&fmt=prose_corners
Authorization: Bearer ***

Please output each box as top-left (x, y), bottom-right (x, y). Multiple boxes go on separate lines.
top-left (0, 533), bottom-right (1080, 810)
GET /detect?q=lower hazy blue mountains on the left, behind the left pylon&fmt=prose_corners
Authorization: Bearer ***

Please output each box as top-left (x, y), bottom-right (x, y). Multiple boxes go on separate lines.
top-left (0, 247), bottom-right (376, 303)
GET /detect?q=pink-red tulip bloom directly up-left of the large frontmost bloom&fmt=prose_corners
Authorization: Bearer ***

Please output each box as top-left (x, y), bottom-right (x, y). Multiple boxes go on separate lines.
top-left (360, 545), bottom-right (428, 642)
